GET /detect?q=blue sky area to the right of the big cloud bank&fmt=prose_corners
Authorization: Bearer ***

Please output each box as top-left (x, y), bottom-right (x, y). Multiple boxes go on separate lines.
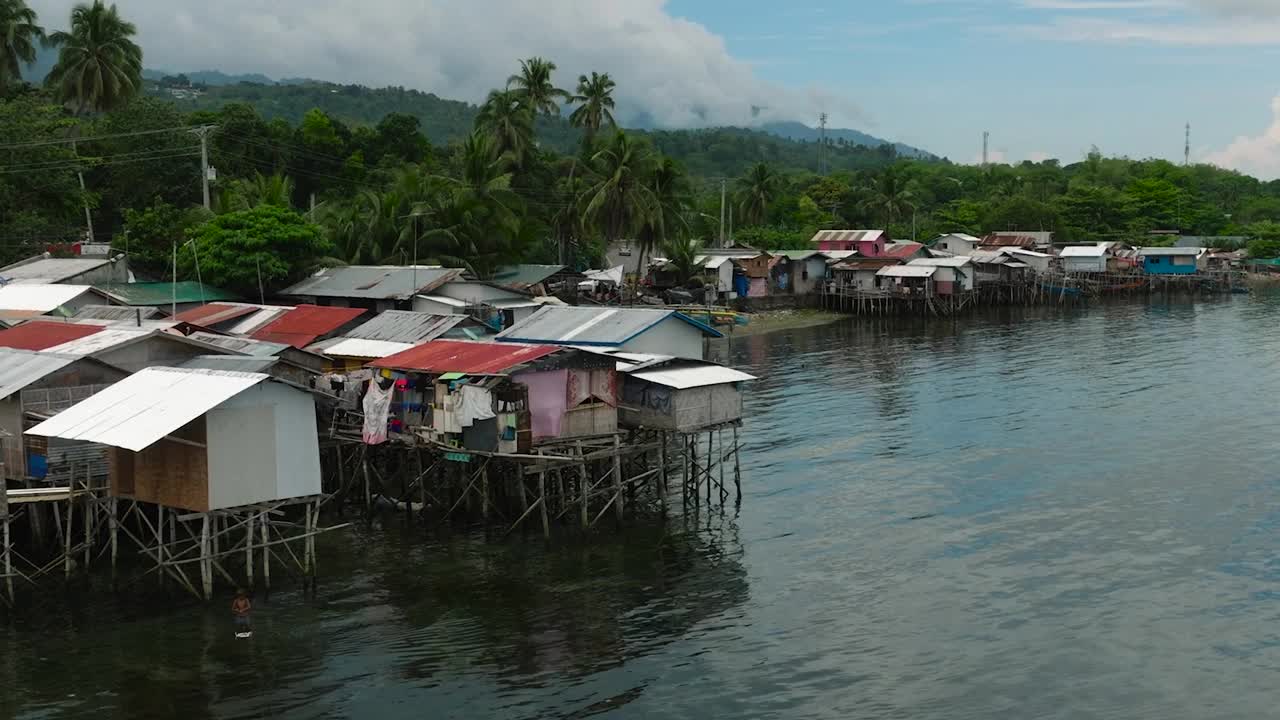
top-left (668, 0), bottom-right (1280, 176)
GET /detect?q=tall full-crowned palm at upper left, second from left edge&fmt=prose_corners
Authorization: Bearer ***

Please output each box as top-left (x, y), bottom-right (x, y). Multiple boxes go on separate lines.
top-left (46, 0), bottom-right (142, 113)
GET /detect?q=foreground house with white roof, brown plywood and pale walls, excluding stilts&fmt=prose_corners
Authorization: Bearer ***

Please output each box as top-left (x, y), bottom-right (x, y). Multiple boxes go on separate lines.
top-left (27, 368), bottom-right (320, 512)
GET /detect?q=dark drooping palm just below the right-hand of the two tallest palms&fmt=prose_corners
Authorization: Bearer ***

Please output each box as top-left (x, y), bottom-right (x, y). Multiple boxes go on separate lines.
top-left (582, 131), bottom-right (658, 268)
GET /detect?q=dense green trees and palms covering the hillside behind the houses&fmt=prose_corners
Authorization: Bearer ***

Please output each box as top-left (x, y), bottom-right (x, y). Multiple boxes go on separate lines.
top-left (0, 0), bottom-right (1280, 290)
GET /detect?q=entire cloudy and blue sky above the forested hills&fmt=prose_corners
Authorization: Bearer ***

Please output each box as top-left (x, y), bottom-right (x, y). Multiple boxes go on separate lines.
top-left (28, 0), bottom-right (1280, 179)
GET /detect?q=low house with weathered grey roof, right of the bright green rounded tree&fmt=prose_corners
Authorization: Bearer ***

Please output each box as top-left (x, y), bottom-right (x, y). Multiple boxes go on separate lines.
top-left (280, 265), bottom-right (462, 313)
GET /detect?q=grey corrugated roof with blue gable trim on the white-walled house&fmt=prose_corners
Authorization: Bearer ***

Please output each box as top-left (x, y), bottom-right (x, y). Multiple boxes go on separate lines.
top-left (497, 305), bottom-right (723, 345)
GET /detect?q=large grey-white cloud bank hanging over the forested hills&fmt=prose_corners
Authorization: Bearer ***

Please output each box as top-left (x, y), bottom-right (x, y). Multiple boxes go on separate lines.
top-left (31, 0), bottom-right (867, 127)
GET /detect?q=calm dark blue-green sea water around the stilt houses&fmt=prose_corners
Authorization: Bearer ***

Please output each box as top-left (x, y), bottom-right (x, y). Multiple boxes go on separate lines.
top-left (0, 297), bottom-right (1280, 720)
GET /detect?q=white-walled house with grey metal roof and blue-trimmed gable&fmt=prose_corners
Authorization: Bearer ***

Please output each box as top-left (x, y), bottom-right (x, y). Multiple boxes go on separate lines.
top-left (495, 305), bottom-right (723, 360)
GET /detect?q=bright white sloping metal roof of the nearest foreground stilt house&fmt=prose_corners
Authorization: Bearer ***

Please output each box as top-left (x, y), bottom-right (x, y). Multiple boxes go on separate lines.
top-left (27, 368), bottom-right (268, 452)
